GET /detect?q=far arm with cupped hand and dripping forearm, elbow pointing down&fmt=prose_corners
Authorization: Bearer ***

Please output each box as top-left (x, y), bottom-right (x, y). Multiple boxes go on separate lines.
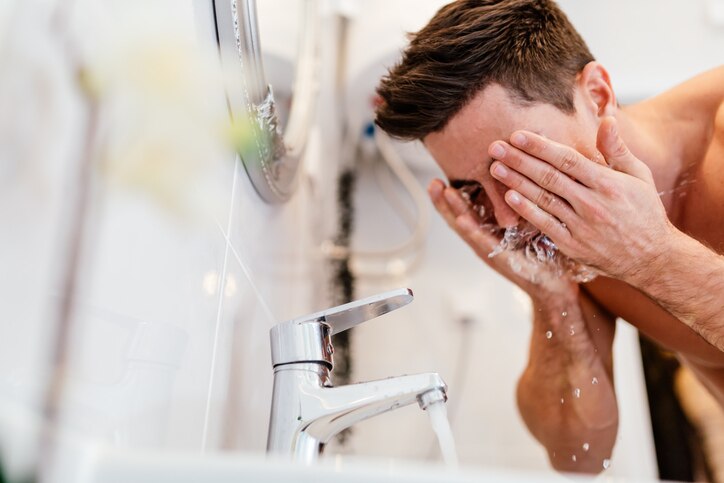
top-left (429, 180), bottom-right (618, 473)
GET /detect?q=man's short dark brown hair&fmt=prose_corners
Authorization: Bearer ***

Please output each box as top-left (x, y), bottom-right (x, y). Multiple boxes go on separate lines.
top-left (375, 0), bottom-right (594, 139)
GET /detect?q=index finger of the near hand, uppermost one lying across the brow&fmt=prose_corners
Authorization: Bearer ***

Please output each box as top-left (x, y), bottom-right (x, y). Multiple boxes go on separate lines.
top-left (510, 131), bottom-right (603, 187)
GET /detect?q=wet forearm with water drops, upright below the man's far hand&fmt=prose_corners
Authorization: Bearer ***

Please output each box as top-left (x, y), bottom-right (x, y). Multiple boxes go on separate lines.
top-left (517, 292), bottom-right (618, 473)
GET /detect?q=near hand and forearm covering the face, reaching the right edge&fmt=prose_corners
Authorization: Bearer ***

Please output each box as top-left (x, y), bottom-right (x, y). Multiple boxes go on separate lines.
top-left (491, 118), bottom-right (724, 351)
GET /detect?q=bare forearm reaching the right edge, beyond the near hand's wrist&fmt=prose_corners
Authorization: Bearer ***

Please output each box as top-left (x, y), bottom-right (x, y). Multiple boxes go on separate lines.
top-left (624, 230), bottom-right (724, 351)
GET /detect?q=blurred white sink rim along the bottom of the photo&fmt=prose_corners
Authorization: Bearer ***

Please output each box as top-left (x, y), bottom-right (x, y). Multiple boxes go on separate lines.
top-left (0, 401), bottom-right (656, 483)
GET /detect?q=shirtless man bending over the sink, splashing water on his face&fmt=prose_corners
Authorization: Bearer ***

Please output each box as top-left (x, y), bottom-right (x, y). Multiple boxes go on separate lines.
top-left (376, 0), bottom-right (724, 472)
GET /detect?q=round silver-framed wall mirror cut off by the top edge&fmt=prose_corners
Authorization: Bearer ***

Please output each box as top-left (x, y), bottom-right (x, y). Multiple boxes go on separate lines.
top-left (212, 0), bottom-right (319, 203)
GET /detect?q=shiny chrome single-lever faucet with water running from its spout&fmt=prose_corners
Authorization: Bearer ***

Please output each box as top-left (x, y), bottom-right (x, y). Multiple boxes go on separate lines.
top-left (267, 289), bottom-right (447, 463)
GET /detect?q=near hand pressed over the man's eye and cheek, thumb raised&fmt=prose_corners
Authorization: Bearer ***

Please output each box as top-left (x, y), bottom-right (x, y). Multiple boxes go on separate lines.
top-left (490, 118), bottom-right (677, 284)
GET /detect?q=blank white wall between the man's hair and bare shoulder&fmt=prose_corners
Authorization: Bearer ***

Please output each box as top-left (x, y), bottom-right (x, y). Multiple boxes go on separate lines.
top-left (559, 0), bottom-right (724, 103)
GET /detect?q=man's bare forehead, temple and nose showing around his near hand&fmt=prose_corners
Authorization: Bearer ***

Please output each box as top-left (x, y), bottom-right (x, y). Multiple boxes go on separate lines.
top-left (423, 84), bottom-right (598, 228)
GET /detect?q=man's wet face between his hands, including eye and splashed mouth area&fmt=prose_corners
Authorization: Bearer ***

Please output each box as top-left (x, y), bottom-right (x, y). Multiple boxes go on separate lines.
top-left (424, 84), bottom-right (595, 280)
